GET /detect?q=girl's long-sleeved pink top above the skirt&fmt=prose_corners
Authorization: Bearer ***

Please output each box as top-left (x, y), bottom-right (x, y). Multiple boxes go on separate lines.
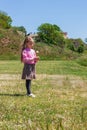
top-left (22, 48), bottom-right (36, 64)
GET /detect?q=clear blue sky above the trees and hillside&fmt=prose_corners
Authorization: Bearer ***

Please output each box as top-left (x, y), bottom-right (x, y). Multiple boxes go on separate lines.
top-left (0, 0), bottom-right (87, 40)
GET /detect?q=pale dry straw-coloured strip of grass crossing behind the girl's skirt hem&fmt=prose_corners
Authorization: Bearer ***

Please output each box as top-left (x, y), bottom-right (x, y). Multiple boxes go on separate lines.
top-left (0, 74), bottom-right (87, 87)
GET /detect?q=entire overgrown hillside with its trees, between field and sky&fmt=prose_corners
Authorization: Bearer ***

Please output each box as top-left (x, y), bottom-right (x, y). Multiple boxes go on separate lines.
top-left (0, 9), bottom-right (87, 60)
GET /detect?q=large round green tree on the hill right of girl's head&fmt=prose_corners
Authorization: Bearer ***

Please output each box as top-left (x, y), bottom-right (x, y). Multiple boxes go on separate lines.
top-left (37, 23), bottom-right (64, 45)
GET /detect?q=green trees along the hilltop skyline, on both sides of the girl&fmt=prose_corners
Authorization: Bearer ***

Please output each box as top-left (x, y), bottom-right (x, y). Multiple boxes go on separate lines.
top-left (0, 11), bottom-right (85, 53)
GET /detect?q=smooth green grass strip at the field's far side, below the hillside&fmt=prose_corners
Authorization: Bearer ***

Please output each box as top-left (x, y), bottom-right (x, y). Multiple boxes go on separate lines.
top-left (0, 60), bottom-right (87, 77)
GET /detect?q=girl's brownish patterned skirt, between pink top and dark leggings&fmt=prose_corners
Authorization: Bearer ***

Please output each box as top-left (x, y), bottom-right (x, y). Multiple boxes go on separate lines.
top-left (22, 63), bottom-right (36, 79)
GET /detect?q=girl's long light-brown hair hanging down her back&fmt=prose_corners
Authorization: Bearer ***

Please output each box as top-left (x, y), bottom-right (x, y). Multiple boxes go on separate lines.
top-left (21, 36), bottom-right (34, 62)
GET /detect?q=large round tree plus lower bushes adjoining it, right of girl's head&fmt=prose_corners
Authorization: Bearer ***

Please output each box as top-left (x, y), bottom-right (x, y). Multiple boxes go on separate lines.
top-left (36, 23), bottom-right (85, 53)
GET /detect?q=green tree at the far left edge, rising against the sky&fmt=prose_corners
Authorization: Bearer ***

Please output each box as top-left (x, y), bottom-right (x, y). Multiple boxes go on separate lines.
top-left (0, 11), bottom-right (12, 29)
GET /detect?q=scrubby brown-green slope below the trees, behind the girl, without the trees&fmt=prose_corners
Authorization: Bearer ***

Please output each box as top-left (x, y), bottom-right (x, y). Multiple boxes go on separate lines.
top-left (0, 28), bottom-right (85, 60)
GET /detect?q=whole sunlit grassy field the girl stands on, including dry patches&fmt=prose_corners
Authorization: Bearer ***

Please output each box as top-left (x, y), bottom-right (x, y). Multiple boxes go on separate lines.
top-left (0, 61), bottom-right (87, 130)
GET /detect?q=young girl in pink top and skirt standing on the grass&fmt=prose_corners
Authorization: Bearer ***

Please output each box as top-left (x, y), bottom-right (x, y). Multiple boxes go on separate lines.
top-left (21, 36), bottom-right (39, 97)
